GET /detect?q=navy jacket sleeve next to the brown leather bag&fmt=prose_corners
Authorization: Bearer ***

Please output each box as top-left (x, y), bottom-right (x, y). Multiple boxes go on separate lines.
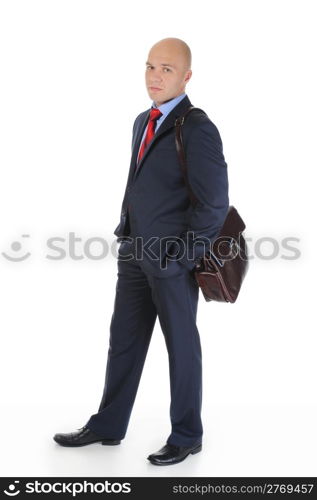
top-left (181, 118), bottom-right (229, 269)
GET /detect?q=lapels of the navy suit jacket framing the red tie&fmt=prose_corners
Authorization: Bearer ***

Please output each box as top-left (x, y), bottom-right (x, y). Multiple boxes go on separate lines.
top-left (129, 95), bottom-right (192, 182)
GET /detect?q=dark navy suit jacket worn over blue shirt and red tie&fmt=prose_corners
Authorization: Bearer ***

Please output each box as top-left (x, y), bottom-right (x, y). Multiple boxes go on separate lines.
top-left (114, 95), bottom-right (229, 277)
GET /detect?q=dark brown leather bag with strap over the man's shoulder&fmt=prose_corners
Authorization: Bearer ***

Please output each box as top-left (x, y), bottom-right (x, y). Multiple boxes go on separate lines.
top-left (175, 106), bottom-right (249, 303)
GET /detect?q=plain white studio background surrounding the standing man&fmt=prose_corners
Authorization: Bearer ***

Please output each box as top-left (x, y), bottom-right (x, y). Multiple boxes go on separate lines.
top-left (0, 0), bottom-right (317, 476)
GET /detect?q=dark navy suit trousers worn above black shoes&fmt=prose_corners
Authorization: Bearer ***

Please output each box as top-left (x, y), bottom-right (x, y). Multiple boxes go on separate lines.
top-left (86, 241), bottom-right (203, 446)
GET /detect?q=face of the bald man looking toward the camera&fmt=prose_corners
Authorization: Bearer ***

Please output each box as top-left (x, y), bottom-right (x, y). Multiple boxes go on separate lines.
top-left (145, 45), bottom-right (192, 106)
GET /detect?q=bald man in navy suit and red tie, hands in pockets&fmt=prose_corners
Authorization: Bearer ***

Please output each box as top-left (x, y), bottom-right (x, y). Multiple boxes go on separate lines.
top-left (54, 38), bottom-right (229, 465)
